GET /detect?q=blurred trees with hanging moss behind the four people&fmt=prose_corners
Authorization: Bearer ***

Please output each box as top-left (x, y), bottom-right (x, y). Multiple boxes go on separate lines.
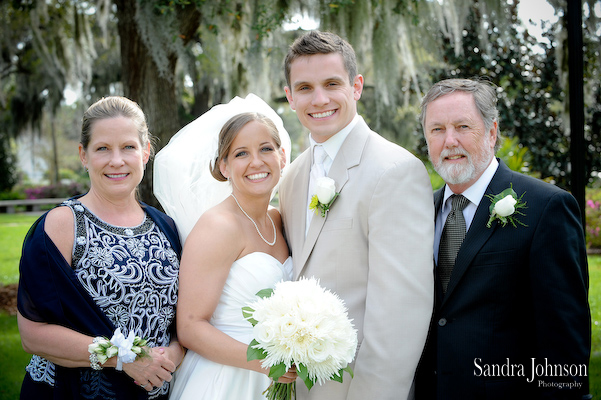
top-left (0, 0), bottom-right (601, 204)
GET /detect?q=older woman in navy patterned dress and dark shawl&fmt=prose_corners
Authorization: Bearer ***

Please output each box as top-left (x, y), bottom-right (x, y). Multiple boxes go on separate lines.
top-left (18, 97), bottom-right (183, 399)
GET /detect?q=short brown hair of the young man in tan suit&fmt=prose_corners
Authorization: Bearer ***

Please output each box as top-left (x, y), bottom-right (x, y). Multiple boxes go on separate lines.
top-left (284, 31), bottom-right (358, 87)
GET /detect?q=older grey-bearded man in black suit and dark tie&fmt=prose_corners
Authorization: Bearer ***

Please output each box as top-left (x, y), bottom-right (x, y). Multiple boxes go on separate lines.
top-left (416, 79), bottom-right (591, 400)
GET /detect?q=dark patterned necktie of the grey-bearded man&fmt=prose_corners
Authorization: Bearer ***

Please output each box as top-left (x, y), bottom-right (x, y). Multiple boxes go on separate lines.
top-left (438, 194), bottom-right (470, 293)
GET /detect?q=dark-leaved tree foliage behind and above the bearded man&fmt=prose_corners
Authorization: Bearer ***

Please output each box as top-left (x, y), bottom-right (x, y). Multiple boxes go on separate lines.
top-left (421, 3), bottom-right (601, 189)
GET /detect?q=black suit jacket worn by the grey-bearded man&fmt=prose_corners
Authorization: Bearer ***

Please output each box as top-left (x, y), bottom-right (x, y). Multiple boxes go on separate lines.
top-left (416, 162), bottom-right (590, 400)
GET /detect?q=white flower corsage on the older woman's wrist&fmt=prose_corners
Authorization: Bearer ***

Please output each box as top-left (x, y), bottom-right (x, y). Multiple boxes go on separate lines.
top-left (88, 328), bottom-right (148, 371)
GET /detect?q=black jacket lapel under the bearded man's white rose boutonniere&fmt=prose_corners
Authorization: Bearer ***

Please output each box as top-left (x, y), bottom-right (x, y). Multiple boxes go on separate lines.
top-left (442, 161), bottom-right (511, 305)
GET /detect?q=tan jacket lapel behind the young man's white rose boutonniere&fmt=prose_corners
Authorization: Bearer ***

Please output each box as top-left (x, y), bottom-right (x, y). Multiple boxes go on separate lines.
top-left (294, 120), bottom-right (369, 279)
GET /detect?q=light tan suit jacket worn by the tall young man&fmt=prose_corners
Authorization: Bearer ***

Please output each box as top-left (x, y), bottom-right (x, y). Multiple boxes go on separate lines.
top-left (280, 120), bottom-right (434, 400)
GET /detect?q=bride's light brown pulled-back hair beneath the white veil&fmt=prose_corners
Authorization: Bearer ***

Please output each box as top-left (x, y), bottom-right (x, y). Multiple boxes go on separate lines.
top-left (209, 112), bottom-right (282, 182)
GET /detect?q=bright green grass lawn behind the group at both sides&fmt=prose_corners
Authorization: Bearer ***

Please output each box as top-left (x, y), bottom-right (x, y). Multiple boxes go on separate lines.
top-left (0, 214), bottom-right (601, 400)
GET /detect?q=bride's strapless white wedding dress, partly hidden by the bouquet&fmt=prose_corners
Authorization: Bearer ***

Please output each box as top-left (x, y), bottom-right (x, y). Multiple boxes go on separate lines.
top-left (169, 252), bottom-right (292, 400)
